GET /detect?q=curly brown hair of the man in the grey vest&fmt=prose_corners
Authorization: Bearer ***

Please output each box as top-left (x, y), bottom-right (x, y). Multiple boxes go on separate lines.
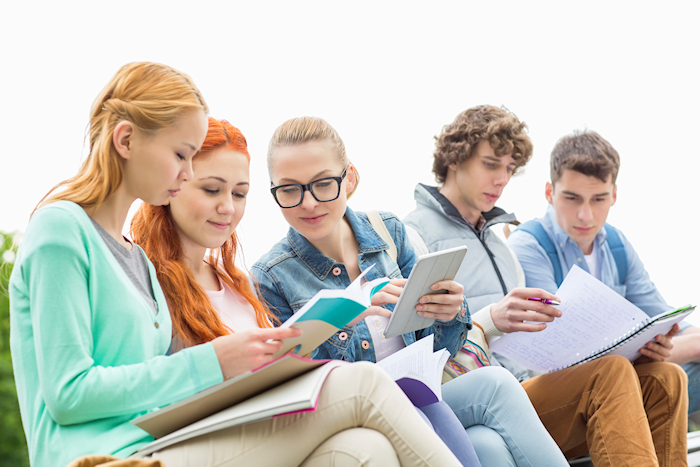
top-left (433, 105), bottom-right (532, 183)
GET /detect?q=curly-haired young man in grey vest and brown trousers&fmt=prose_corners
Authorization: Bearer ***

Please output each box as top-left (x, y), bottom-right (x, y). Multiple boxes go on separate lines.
top-left (404, 106), bottom-right (688, 467)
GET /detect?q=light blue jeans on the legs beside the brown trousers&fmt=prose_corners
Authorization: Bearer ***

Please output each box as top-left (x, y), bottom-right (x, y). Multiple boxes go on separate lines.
top-left (442, 367), bottom-right (569, 467)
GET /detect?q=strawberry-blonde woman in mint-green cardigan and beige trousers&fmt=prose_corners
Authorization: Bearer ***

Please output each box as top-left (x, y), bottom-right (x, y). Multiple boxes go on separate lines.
top-left (10, 63), bottom-right (459, 467)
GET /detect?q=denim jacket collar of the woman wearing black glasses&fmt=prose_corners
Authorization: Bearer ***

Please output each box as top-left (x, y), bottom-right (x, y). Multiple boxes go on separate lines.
top-left (287, 207), bottom-right (389, 280)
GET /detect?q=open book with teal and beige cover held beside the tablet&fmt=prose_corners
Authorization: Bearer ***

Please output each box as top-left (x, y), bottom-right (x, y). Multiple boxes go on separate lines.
top-left (275, 265), bottom-right (389, 357)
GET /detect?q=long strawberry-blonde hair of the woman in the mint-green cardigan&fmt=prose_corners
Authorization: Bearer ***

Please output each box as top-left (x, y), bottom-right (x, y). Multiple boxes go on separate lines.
top-left (37, 62), bottom-right (209, 212)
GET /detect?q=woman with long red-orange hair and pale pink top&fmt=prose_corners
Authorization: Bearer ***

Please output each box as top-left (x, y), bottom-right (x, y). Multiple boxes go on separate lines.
top-left (131, 118), bottom-right (276, 352)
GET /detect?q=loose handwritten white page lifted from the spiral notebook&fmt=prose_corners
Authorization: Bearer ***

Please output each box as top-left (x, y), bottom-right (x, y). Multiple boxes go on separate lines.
top-left (490, 266), bottom-right (648, 371)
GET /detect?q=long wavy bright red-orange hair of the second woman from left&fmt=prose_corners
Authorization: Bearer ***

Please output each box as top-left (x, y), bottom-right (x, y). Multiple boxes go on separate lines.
top-left (131, 118), bottom-right (277, 346)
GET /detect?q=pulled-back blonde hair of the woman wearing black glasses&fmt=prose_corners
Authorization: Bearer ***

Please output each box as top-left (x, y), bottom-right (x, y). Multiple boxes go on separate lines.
top-left (267, 117), bottom-right (360, 198)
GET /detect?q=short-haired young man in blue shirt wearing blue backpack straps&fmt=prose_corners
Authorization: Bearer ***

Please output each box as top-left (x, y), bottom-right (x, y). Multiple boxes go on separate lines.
top-left (508, 131), bottom-right (700, 413)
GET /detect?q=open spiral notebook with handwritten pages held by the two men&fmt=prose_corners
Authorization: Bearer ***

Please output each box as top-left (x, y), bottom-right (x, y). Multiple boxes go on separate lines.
top-left (489, 266), bottom-right (695, 372)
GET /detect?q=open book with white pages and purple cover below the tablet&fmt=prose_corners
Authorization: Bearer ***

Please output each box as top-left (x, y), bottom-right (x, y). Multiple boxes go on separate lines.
top-left (377, 334), bottom-right (450, 407)
